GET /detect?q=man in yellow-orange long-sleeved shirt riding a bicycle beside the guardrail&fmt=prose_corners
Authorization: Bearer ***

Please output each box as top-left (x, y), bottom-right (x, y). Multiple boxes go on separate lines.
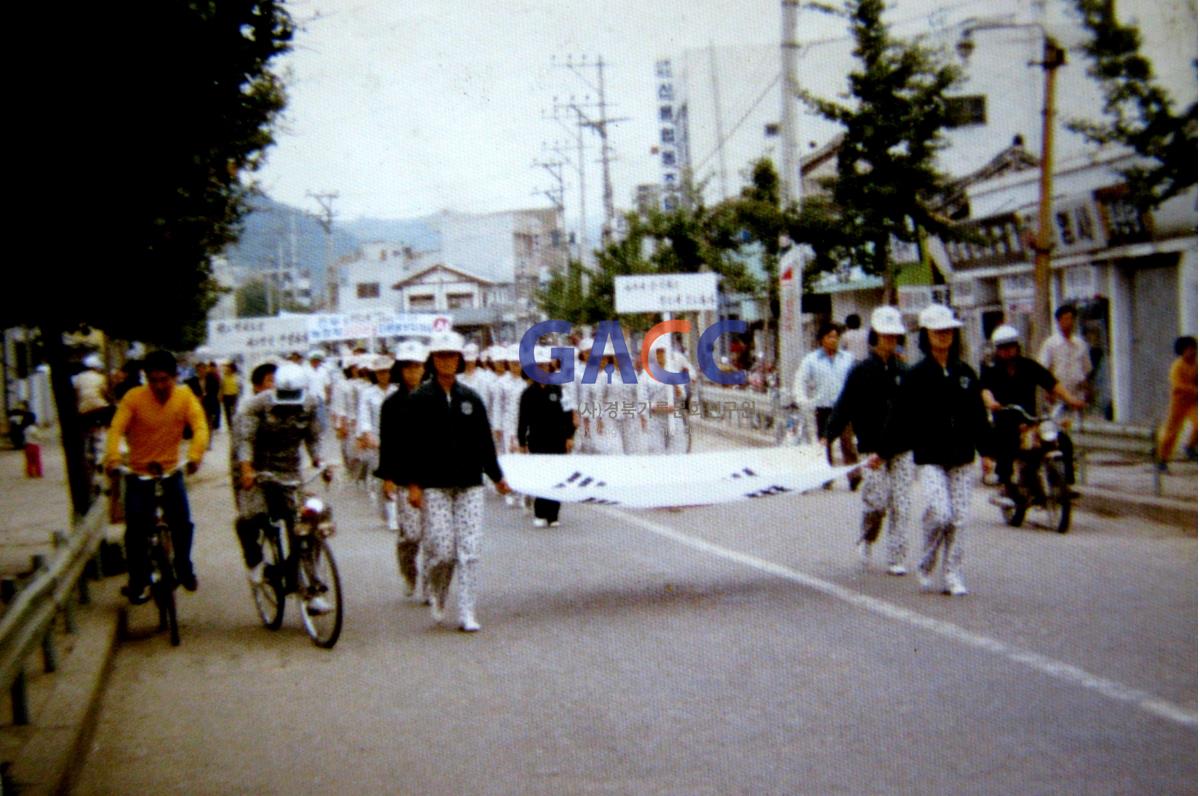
top-left (104, 351), bottom-right (209, 605)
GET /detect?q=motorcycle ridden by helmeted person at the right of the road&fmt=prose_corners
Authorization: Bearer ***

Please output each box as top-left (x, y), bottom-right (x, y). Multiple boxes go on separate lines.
top-left (995, 403), bottom-right (1072, 533)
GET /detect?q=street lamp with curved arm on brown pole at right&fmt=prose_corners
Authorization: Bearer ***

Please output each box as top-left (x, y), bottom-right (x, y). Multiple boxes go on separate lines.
top-left (955, 23), bottom-right (1067, 351)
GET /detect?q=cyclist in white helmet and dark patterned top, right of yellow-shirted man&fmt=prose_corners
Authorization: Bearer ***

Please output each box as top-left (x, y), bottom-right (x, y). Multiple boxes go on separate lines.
top-left (235, 363), bottom-right (322, 610)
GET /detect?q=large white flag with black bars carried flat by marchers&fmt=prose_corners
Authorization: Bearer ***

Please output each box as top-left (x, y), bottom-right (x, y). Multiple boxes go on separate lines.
top-left (500, 445), bottom-right (857, 509)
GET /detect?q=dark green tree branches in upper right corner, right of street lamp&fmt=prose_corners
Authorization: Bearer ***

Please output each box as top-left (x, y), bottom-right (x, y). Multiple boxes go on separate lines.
top-left (1070, 0), bottom-right (1196, 210)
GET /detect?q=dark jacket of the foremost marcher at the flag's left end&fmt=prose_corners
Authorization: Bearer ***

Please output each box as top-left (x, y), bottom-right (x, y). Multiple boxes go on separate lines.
top-left (392, 379), bottom-right (504, 489)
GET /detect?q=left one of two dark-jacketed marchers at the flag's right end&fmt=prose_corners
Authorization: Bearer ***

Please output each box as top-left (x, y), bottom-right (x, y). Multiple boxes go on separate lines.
top-left (822, 306), bottom-right (913, 575)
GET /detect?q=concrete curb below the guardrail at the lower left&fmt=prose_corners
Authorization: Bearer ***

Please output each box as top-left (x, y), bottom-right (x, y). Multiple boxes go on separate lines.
top-left (8, 577), bottom-right (121, 794)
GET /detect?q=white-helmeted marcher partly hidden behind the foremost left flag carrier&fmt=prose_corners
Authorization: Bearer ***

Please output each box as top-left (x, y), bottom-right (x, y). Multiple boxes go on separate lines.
top-left (376, 340), bottom-right (428, 599)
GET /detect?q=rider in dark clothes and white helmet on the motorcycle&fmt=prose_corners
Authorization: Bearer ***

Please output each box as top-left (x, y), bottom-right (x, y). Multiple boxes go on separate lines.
top-left (979, 323), bottom-right (1086, 501)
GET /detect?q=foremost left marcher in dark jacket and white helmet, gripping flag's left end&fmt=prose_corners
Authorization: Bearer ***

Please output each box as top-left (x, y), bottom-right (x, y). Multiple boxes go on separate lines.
top-left (397, 331), bottom-right (512, 633)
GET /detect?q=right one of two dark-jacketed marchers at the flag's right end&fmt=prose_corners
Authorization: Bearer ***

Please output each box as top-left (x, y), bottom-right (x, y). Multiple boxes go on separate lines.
top-left (898, 304), bottom-right (988, 597)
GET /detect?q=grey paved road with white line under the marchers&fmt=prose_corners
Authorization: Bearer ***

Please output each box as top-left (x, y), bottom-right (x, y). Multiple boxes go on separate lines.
top-left (78, 439), bottom-right (1198, 794)
